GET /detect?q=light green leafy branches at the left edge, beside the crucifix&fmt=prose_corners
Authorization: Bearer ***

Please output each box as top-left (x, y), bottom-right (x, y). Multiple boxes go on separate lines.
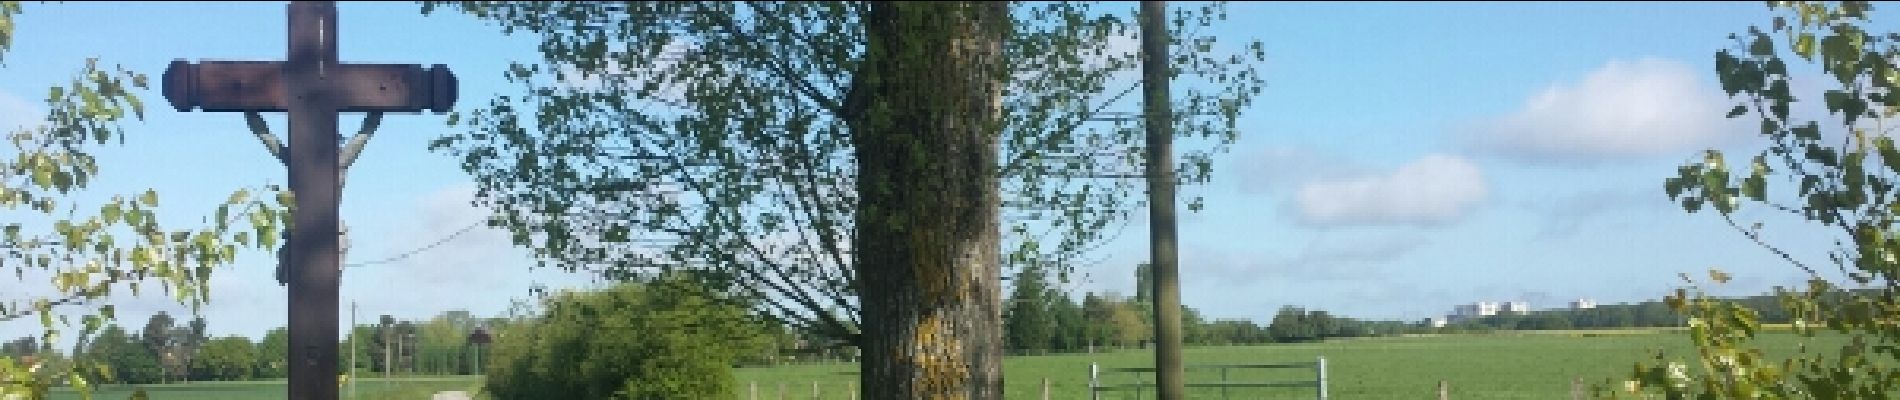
top-left (0, 2), bottom-right (285, 396)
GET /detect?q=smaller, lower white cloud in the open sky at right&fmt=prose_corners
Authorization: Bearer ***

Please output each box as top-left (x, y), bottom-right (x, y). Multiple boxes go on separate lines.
top-left (1294, 155), bottom-right (1490, 226)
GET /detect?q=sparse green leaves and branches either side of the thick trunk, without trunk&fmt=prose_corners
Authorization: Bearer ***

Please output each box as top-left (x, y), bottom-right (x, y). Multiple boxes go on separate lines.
top-left (424, 2), bottom-right (1264, 343)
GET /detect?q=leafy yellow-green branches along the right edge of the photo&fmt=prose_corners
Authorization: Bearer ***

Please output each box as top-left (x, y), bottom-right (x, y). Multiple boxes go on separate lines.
top-left (1600, 2), bottom-right (1900, 398)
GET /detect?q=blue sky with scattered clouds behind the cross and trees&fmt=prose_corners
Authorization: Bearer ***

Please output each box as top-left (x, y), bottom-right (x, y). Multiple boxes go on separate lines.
top-left (0, 2), bottom-right (1854, 343)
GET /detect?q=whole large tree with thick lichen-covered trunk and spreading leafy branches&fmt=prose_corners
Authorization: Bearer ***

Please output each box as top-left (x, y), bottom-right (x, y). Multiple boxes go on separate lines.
top-left (416, 2), bottom-right (1262, 398)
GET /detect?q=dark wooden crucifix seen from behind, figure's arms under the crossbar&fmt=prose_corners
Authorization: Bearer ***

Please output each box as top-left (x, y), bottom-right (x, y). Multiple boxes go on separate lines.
top-left (163, 2), bottom-right (456, 400)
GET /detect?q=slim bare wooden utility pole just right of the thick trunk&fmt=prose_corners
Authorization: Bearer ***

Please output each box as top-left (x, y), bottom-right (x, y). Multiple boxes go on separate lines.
top-left (1140, 0), bottom-right (1186, 400)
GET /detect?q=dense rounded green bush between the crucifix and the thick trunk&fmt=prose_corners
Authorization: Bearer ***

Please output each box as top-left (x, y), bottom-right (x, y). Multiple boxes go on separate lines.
top-left (485, 277), bottom-right (768, 398)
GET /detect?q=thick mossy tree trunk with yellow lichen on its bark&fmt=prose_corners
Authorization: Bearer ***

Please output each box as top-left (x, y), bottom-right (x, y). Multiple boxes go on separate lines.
top-left (847, 2), bottom-right (1009, 400)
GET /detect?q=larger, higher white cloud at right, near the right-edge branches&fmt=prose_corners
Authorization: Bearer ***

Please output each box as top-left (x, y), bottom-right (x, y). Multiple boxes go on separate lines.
top-left (1469, 59), bottom-right (1746, 161)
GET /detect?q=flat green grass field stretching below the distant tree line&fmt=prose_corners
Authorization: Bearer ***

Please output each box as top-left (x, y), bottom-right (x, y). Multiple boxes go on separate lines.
top-left (53, 330), bottom-right (1837, 400)
